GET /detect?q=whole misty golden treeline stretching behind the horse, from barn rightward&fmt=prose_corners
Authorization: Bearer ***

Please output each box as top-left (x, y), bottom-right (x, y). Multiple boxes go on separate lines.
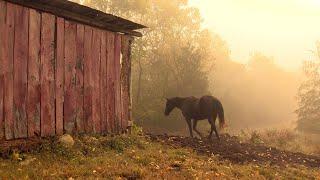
top-left (71, 0), bottom-right (318, 135)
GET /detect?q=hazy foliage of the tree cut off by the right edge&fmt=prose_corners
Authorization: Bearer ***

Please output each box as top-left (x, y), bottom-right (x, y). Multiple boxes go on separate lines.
top-left (296, 42), bottom-right (320, 134)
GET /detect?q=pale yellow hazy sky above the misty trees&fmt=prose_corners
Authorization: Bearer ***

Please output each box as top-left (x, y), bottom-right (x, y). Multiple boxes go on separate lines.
top-left (189, 0), bottom-right (320, 70)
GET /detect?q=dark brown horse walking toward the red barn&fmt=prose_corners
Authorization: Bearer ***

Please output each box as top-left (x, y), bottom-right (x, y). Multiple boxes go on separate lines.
top-left (164, 96), bottom-right (225, 140)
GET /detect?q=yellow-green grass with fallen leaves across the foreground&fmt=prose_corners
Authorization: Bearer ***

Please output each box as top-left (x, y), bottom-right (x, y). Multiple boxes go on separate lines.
top-left (0, 135), bottom-right (320, 179)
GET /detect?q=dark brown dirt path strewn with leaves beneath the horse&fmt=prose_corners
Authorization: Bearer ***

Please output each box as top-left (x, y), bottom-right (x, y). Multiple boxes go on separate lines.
top-left (147, 134), bottom-right (320, 168)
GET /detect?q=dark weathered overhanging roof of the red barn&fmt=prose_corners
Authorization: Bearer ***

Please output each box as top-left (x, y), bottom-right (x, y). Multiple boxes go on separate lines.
top-left (5, 0), bottom-right (146, 37)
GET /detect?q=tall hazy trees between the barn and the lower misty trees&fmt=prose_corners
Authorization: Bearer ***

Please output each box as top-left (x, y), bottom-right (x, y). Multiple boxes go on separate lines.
top-left (71, 0), bottom-right (214, 130)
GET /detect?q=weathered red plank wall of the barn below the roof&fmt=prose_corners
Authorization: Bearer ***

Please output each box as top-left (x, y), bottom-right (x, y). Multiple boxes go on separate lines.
top-left (0, 0), bottom-right (131, 140)
